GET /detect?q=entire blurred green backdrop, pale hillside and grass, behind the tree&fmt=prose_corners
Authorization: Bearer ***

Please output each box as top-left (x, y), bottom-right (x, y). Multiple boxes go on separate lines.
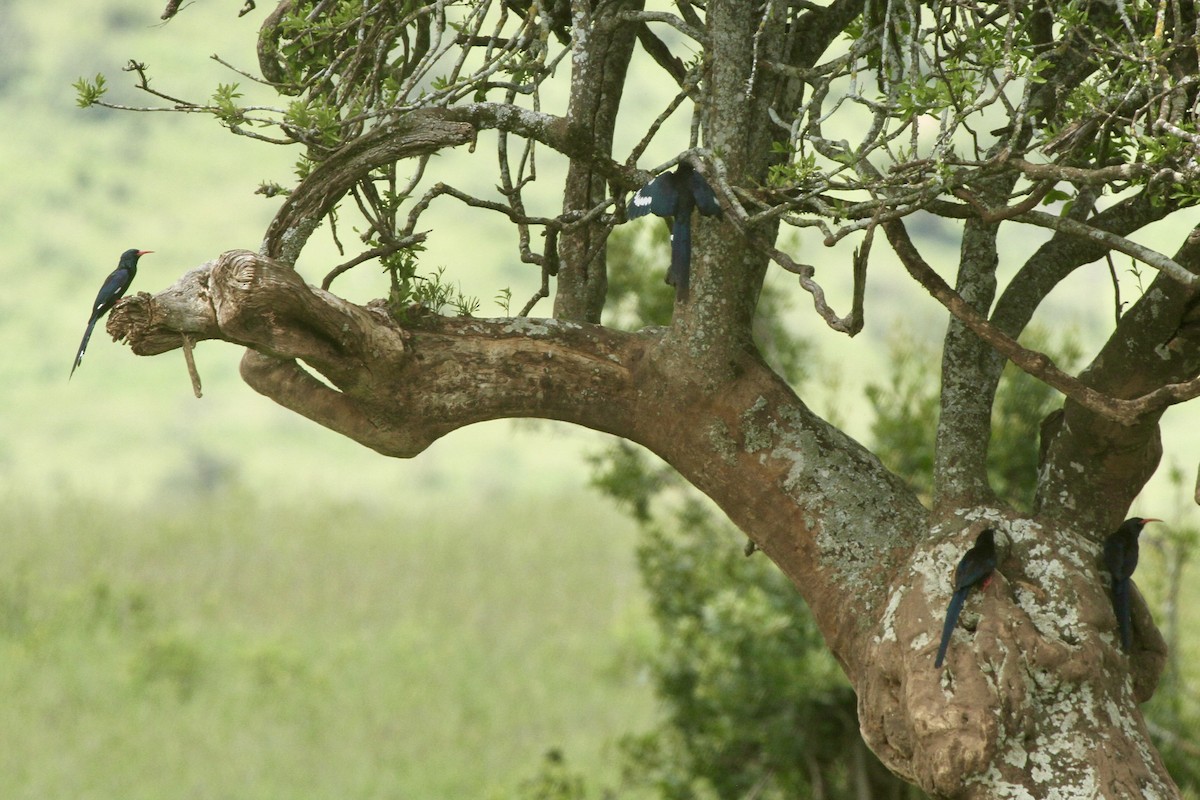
top-left (0, 0), bottom-right (1200, 798)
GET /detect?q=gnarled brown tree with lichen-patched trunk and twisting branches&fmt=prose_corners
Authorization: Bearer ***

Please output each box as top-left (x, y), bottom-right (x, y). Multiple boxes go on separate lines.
top-left (96, 0), bottom-right (1200, 798)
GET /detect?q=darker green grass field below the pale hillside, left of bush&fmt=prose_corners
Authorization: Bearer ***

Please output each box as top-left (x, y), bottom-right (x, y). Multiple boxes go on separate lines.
top-left (0, 494), bottom-right (654, 800)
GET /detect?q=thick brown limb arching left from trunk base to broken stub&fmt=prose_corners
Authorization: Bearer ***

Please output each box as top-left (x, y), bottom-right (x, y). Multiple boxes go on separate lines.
top-left (109, 251), bottom-right (926, 714)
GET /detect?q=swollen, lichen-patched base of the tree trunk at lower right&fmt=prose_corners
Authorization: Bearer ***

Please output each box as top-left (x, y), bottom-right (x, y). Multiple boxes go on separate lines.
top-left (859, 509), bottom-right (1177, 799)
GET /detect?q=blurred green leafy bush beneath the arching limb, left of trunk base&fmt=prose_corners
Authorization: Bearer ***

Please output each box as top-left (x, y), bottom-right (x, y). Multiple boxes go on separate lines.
top-left (623, 498), bottom-right (918, 800)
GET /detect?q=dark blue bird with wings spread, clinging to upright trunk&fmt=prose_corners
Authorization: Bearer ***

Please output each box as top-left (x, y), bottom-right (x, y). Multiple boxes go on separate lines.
top-left (625, 161), bottom-right (721, 300)
